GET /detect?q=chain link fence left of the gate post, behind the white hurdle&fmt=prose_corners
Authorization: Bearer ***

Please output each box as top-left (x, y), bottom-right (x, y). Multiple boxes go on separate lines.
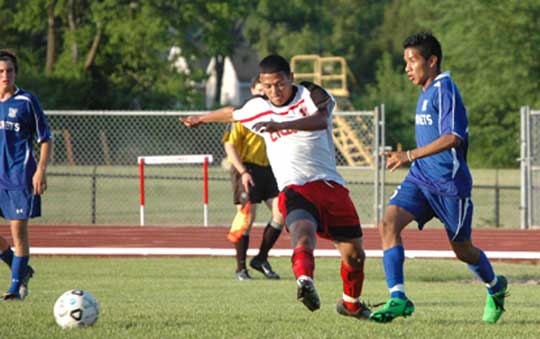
top-left (41, 111), bottom-right (377, 225)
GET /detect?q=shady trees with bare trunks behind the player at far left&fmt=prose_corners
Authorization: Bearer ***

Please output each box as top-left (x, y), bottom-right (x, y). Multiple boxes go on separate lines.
top-left (0, 0), bottom-right (206, 109)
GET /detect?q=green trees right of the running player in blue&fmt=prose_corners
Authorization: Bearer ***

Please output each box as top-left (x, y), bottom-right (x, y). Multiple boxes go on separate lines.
top-left (408, 0), bottom-right (540, 166)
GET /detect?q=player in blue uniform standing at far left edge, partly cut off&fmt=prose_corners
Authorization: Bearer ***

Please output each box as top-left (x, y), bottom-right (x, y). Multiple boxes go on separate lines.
top-left (0, 50), bottom-right (51, 300)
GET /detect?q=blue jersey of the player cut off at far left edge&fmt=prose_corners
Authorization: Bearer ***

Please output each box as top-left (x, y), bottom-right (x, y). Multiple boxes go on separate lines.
top-left (0, 88), bottom-right (51, 190)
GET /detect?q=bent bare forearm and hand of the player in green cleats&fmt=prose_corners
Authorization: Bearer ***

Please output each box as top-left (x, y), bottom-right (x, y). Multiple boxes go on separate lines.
top-left (383, 134), bottom-right (461, 172)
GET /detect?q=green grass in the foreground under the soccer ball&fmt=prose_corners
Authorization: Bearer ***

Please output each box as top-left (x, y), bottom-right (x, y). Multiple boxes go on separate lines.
top-left (0, 257), bottom-right (540, 339)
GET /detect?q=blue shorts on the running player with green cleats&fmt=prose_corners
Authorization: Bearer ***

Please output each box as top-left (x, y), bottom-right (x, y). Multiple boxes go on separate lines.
top-left (388, 180), bottom-right (473, 242)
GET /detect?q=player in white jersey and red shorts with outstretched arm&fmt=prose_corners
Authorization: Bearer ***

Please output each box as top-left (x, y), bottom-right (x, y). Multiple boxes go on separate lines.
top-left (183, 55), bottom-right (370, 319)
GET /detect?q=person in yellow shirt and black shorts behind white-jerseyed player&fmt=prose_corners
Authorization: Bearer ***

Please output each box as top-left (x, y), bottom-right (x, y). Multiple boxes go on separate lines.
top-left (223, 77), bottom-right (283, 280)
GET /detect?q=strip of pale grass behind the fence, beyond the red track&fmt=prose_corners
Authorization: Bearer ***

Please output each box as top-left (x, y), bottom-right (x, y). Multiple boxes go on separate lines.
top-left (41, 166), bottom-right (520, 228)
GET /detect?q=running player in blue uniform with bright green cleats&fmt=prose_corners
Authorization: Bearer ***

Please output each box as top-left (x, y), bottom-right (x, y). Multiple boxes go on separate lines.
top-left (371, 33), bottom-right (507, 323)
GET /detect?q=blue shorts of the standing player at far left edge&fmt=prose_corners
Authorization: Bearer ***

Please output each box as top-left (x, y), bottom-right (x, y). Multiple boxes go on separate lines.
top-left (0, 189), bottom-right (41, 220)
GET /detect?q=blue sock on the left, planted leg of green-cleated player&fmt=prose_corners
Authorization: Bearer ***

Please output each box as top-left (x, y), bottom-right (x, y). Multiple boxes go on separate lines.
top-left (383, 245), bottom-right (407, 299)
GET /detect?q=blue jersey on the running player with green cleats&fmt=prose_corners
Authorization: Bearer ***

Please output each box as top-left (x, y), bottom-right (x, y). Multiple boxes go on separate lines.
top-left (407, 72), bottom-right (472, 198)
